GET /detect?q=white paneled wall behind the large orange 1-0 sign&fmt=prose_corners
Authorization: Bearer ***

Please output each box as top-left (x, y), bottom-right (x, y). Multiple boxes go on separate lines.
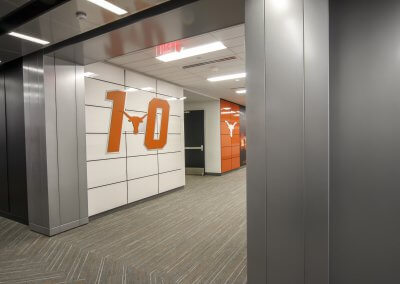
top-left (85, 63), bottom-right (185, 216)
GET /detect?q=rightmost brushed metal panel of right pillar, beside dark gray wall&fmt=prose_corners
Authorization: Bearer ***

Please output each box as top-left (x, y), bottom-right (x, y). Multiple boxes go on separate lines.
top-left (304, 0), bottom-right (329, 284)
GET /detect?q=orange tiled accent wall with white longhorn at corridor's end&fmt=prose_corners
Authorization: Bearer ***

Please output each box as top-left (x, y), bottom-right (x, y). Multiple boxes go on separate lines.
top-left (220, 100), bottom-right (240, 173)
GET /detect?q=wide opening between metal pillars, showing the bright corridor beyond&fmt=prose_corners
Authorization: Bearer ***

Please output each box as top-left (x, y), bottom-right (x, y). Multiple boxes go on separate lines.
top-left (79, 25), bottom-right (247, 283)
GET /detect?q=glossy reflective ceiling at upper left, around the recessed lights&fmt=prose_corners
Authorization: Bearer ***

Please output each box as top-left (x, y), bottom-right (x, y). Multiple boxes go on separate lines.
top-left (0, 0), bottom-right (169, 62)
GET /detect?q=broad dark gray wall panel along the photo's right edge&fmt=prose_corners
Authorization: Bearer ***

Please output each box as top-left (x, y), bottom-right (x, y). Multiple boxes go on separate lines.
top-left (330, 0), bottom-right (400, 284)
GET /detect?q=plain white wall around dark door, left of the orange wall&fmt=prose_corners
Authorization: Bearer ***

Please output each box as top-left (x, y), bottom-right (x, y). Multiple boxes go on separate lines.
top-left (184, 100), bottom-right (221, 173)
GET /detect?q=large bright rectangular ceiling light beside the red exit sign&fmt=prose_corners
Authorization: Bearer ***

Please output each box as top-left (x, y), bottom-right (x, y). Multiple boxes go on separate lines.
top-left (156, 41), bottom-right (226, 62)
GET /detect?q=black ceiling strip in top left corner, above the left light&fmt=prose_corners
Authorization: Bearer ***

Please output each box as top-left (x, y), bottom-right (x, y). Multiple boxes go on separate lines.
top-left (0, 0), bottom-right (71, 35)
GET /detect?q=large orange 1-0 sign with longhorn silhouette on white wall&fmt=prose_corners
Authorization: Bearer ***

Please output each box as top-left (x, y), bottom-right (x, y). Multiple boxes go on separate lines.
top-left (107, 91), bottom-right (170, 153)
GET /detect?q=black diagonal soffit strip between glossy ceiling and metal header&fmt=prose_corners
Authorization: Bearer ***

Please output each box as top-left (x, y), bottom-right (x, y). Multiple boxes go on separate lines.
top-left (43, 0), bottom-right (199, 54)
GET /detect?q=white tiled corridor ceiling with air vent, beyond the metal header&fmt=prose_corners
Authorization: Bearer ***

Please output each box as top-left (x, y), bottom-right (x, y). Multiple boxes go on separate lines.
top-left (108, 25), bottom-right (246, 105)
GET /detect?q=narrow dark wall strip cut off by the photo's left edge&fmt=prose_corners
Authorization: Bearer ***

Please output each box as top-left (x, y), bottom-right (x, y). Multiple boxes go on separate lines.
top-left (0, 72), bottom-right (9, 212)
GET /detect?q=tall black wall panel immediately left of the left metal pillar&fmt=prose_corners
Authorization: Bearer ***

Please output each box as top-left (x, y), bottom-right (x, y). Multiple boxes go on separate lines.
top-left (5, 60), bottom-right (28, 222)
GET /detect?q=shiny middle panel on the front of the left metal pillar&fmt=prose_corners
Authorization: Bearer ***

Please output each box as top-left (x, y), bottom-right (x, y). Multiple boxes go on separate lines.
top-left (55, 59), bottom-right (80, 224)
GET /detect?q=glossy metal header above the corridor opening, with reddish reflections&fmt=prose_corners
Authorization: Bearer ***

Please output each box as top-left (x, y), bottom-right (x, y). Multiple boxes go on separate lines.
top-left (51, 0), bottom-right (244, 65)
